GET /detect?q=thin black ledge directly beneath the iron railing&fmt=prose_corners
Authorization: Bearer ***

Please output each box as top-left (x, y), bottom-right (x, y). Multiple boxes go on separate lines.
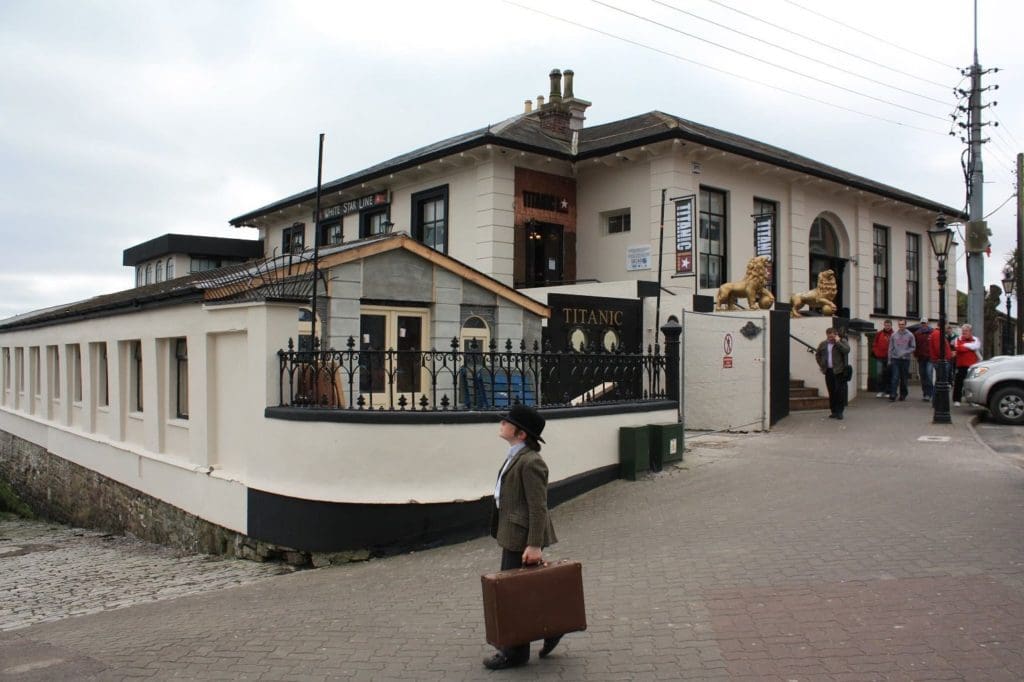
top-left (263, 399), bottom-right (679, 424)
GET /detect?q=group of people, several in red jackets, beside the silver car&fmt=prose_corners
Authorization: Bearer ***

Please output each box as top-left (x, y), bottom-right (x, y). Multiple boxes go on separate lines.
top-left (871, 319), bottom-right (981, 407)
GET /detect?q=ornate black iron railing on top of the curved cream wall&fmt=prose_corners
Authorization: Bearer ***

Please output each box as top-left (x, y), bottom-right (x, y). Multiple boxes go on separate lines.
top-left (278, 337), bottom-right (666, 411)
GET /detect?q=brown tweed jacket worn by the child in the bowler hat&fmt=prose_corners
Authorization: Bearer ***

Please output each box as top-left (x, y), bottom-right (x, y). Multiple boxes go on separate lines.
top-left (490, 447), bottom-right (558, 552)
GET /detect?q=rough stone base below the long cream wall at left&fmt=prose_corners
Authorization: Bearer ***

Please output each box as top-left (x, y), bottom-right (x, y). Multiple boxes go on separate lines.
top-left (0, 431), bottom-right (305, 565)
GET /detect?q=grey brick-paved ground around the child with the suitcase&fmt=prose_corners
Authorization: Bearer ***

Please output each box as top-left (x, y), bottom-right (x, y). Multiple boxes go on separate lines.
top-left (0, 397), bottom-right (1024, 681)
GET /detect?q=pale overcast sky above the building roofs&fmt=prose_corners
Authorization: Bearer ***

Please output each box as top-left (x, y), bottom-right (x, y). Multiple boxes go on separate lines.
top-left (0, 0), bottom-right (1024, 318)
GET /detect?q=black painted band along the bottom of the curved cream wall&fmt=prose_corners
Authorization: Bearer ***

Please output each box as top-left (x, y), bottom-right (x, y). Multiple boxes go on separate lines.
top-left (248, 465), bottom-right (618, 555)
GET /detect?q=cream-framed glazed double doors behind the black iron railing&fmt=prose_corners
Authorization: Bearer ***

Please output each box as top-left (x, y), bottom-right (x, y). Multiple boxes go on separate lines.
top-left (359, 307), bottom-right (429, 409)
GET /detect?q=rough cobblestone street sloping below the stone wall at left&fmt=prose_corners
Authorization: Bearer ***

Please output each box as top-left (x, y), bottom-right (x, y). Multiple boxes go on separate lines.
top-left (0, 516), bottom-right (292, 631)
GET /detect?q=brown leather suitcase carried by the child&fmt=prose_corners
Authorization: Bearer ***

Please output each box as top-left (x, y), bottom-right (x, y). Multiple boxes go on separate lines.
top-left (480, 560), bottom-right (587, 648)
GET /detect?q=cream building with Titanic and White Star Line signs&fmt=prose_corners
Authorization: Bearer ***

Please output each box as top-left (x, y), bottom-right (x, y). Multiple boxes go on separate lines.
top-left (0, 67), bottom-right (959, 555)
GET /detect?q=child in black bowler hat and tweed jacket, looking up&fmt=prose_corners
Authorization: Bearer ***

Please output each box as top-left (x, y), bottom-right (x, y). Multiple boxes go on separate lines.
top-left (483, 404), bottom-right (561, 670)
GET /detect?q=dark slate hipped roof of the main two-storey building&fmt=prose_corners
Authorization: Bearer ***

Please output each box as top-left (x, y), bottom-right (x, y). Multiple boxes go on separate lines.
top-left (230, 111), bottom-right (967, 226)
